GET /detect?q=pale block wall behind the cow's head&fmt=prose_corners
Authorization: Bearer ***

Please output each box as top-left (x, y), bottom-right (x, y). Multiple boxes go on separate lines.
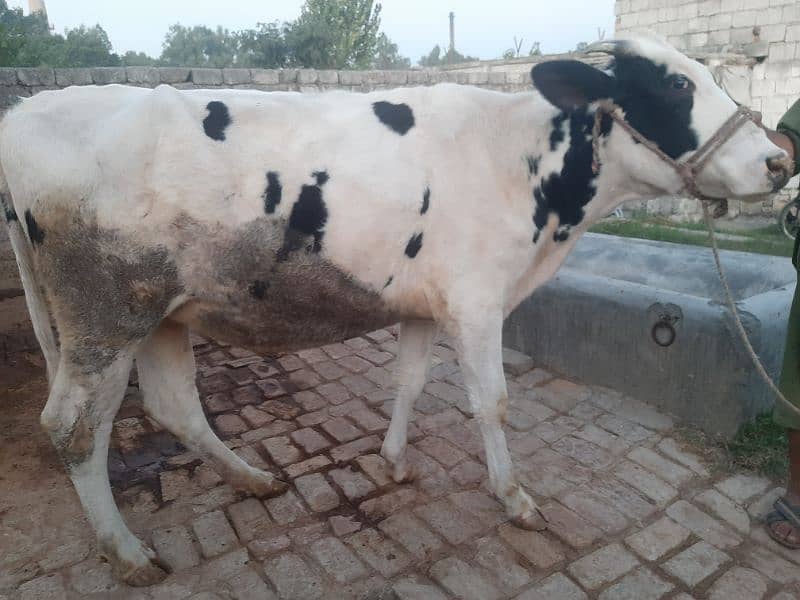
top-left (615, 0), bottom-right (800, 217)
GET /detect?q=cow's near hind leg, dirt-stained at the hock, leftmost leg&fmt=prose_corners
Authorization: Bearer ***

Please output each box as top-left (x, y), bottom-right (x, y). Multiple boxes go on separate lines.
top-left (41, 348), bottom-right (166, 585)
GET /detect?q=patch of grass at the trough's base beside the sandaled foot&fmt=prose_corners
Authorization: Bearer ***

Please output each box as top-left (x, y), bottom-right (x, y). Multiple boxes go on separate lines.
top-left (676, 414), bottom-right (789, 481)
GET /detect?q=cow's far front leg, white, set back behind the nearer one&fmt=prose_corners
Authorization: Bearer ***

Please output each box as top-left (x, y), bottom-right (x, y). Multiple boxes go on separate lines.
top-left (381, 321), bottom-right (437, 483)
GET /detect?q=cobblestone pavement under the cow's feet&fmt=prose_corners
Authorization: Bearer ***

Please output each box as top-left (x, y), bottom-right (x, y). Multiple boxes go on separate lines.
top-left (0, 330), bottom-right (800, 600)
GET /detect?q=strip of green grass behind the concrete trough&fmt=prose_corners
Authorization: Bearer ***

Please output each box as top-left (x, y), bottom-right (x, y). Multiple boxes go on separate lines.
top-left (590, 217), bottom-right (792, 256)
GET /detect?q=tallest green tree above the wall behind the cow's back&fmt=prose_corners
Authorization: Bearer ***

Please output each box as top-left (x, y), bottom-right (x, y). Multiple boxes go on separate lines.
top-left (285, 0), bottom-right (381, 69)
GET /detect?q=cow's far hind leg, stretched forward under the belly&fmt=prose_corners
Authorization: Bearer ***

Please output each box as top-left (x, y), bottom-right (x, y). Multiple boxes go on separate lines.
top-left (136, 320), bottom-right (287, 497)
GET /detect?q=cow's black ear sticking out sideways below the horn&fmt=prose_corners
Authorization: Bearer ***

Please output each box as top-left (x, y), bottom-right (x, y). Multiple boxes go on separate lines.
top-left (531, 60), bottom-right (616, 111)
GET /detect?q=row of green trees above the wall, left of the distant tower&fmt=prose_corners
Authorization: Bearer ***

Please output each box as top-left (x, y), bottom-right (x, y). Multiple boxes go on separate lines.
top-left (0, 0), bottom-right (410, 69)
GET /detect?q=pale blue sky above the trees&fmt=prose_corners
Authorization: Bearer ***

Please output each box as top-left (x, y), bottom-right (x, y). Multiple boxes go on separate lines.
top-left (8, 0), bottom-right (614, 62)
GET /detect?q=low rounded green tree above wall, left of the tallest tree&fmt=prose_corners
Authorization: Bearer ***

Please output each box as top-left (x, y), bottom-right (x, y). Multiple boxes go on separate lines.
top-left (161, 23), bottom-right (238, 67)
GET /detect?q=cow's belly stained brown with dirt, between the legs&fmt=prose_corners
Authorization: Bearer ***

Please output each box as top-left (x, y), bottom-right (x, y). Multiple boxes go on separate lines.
top-left (170, 219), bottom-right (403, 353)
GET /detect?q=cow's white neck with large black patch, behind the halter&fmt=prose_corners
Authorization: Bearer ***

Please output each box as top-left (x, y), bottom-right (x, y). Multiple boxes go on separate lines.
top-left (492, 93), bottom-right (659, 310)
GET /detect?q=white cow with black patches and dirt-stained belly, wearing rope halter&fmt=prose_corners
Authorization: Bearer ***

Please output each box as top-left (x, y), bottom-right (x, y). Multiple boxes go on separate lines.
top-left (0, 36), bottom-right (789, 585)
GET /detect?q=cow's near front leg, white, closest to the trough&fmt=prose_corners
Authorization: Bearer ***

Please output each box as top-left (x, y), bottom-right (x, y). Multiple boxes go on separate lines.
top-left (455, 311), bottom-right (546, 530)
